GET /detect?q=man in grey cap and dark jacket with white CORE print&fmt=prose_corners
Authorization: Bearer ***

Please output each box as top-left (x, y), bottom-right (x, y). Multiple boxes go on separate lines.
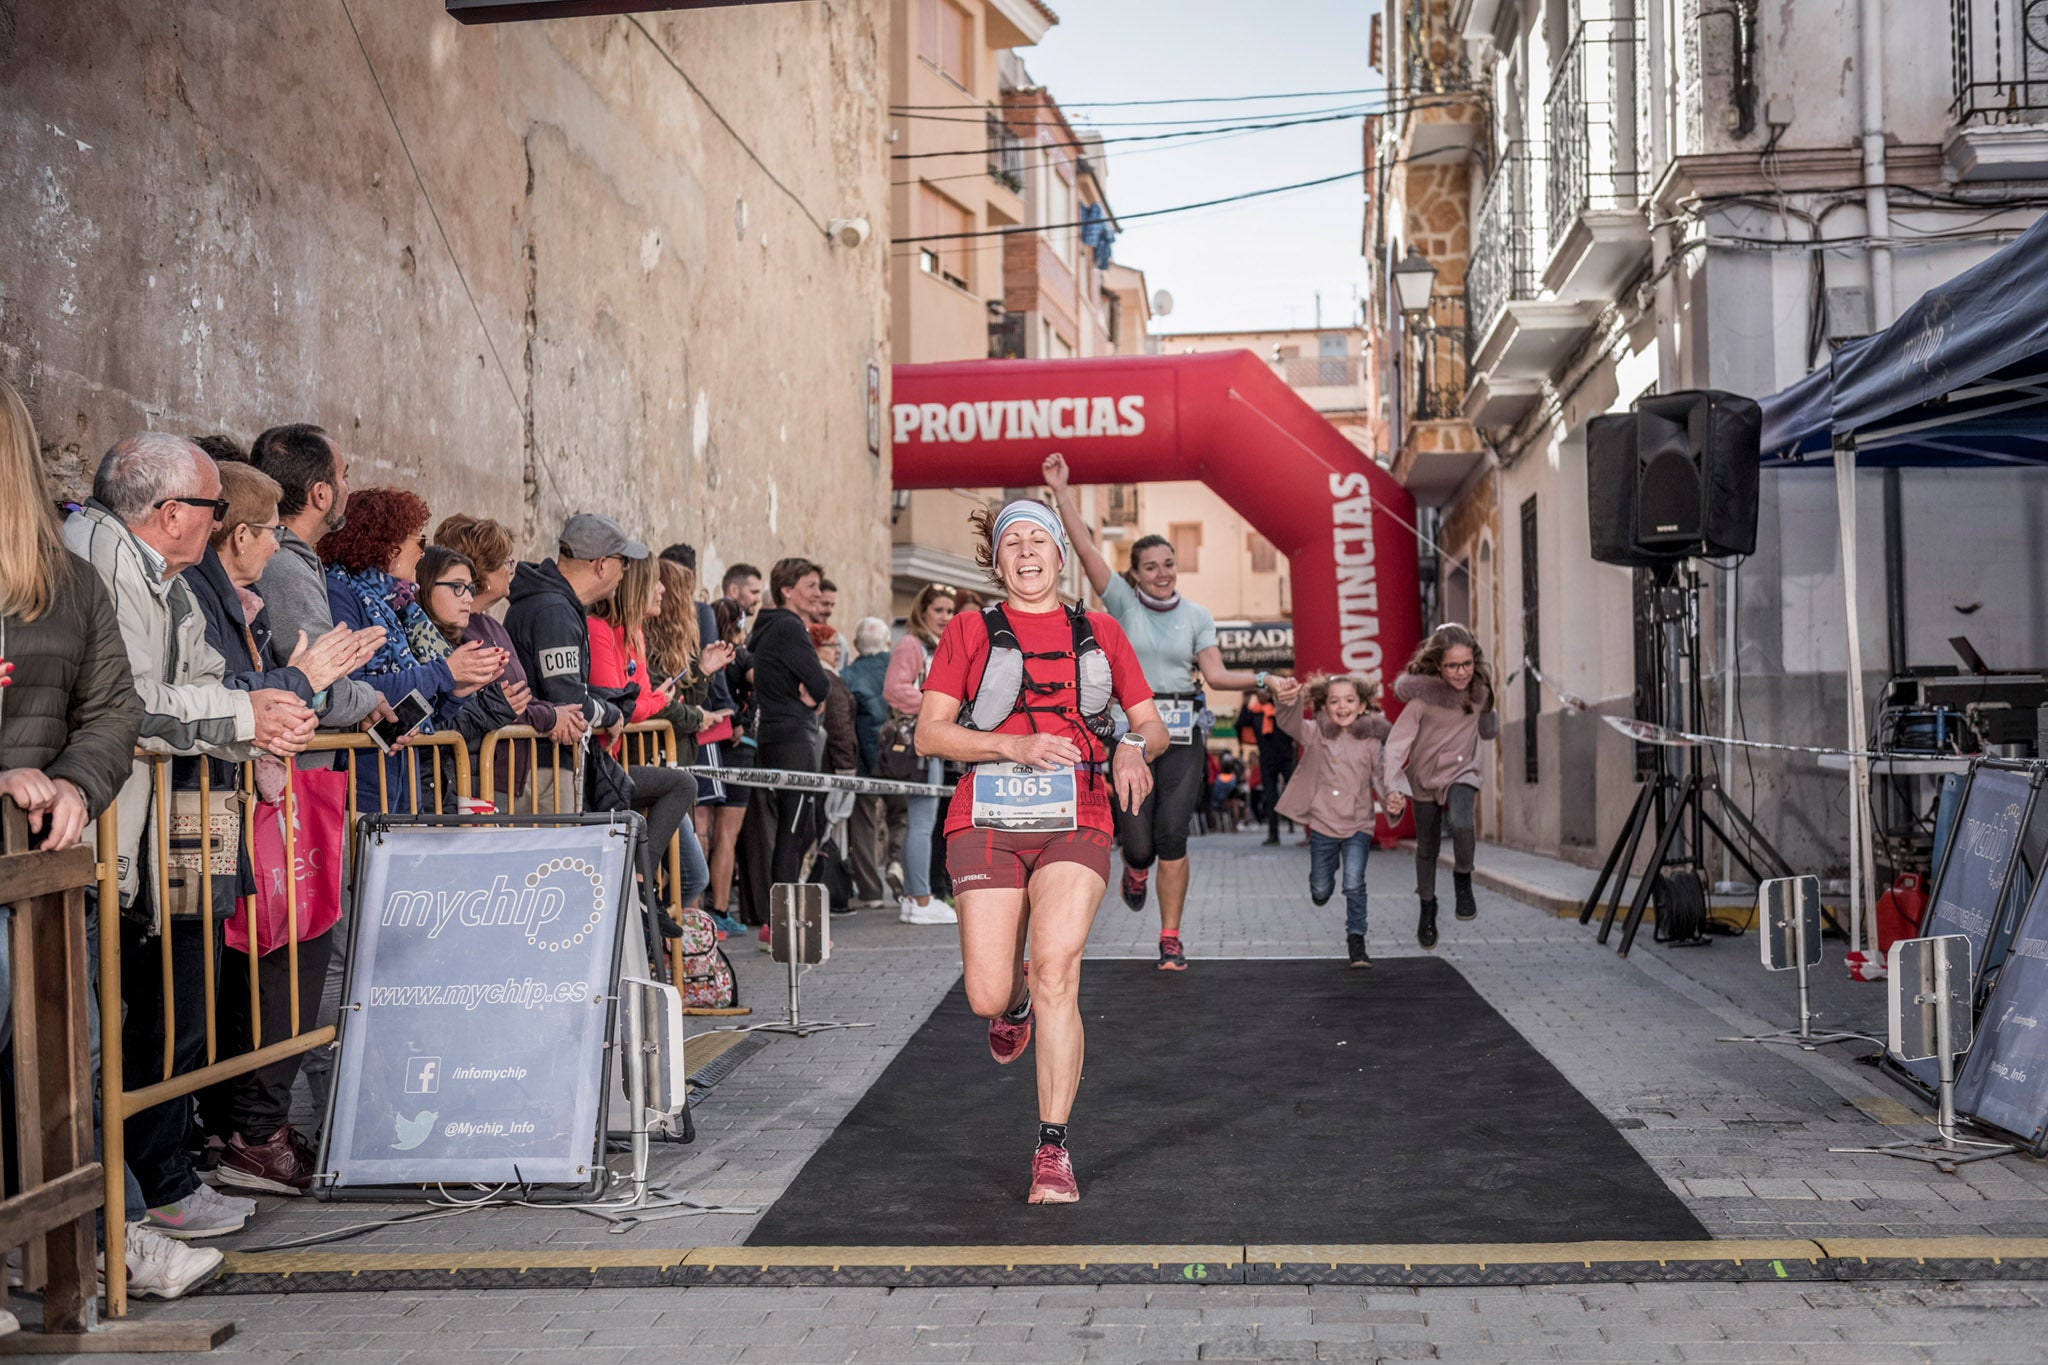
top-left (506, 512), bottom-right (647, 785)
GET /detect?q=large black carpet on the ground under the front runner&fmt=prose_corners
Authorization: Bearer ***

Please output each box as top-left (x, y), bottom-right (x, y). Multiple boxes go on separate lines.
top-left (748, 958), bottom-right (1706, 1246)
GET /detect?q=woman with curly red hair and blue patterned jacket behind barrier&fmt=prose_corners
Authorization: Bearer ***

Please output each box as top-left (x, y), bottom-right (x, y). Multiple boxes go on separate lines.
top-left (317, 489), bottom-right (506, 810)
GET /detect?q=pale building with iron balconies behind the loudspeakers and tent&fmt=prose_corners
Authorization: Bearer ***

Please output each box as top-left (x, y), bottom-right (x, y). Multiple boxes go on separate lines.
top-left (1366, 0), bottom-right (2048, 870)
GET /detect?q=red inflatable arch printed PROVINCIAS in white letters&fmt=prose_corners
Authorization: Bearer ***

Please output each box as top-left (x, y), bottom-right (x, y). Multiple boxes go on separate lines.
top-left (893, 350), bottom-right (1421, 677)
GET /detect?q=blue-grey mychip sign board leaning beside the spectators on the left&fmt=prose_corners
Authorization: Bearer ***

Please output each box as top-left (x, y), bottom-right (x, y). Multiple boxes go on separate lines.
top-left (322, 817), bottom-right (635, 1189)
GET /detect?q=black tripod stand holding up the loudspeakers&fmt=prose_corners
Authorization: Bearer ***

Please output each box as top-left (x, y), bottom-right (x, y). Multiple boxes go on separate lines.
top-left (1579, 565), bottom-right (1792, 958)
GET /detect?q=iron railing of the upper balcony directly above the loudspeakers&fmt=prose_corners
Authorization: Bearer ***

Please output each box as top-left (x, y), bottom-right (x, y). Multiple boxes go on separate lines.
top-left (1544, 18), bottom-right (1649, 244)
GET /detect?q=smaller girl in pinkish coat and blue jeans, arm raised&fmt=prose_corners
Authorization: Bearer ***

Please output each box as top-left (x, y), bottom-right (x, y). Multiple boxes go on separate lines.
top-left (1274, 673), bottom-right (1393, 966)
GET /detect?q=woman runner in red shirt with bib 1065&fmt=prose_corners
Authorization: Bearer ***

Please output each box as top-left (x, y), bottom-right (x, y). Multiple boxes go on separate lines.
top-left (918, 499), bottom-right (1167, 1203)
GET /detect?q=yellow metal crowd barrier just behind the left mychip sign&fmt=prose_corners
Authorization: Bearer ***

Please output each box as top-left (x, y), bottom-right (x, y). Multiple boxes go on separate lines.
top-left (96, 733), bottom-right (471, 1318)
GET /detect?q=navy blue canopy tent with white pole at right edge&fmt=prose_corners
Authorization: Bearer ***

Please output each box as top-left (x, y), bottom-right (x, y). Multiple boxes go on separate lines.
top-left (1761, 217), bottom-right (2048, 950)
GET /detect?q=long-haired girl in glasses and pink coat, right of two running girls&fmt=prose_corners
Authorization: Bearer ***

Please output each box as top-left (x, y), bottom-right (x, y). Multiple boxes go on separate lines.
top-left (1384, 622), bottom-right (1501, 948)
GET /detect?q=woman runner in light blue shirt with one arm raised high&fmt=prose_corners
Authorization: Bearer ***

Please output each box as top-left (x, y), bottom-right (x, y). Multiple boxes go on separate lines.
top-left (1044, 454), bottom-right (1266, 972)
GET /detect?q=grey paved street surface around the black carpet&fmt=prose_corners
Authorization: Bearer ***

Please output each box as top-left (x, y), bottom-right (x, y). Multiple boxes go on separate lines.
top-left (68, 833), bottom-right (2048, 1363)
